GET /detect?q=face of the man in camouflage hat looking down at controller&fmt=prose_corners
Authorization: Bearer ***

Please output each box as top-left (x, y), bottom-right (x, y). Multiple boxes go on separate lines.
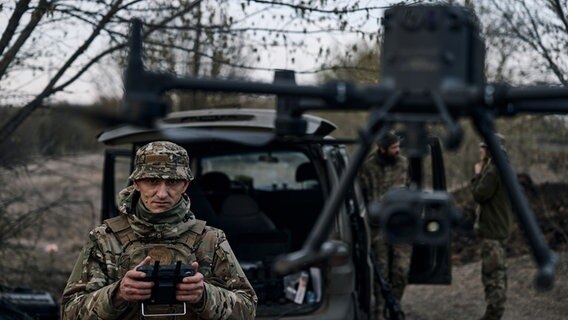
top-left (134, 179), bottom-right (189, 214)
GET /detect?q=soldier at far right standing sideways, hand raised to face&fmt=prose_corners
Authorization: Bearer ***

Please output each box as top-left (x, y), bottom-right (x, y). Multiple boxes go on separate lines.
top-left (471, 135), bottom-right (512, 320)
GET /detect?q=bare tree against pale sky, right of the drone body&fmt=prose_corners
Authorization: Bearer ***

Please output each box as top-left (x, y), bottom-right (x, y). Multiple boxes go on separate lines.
top-left (475, 0), bottom-right (568, 85)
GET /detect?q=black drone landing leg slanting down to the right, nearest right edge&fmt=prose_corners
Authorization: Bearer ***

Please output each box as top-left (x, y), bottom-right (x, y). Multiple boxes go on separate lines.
top-left (474, 109), bottom-right (557, 289)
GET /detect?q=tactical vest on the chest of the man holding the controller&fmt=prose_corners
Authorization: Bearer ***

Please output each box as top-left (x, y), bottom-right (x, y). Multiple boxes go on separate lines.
top-left (104, 215), bottom-right (206, 277)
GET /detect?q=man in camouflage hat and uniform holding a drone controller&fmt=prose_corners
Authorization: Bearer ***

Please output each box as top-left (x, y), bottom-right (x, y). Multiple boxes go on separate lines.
top-left (62, 141), bottom-right (257, 320)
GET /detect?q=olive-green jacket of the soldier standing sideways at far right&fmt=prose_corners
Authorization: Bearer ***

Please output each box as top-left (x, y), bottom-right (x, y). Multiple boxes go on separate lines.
top-left (471, 164), bottom-right (512, 240)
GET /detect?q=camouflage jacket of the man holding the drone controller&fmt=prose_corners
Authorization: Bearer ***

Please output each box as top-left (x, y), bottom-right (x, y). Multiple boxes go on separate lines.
top-left (62, 188), bottom-right (257, 320)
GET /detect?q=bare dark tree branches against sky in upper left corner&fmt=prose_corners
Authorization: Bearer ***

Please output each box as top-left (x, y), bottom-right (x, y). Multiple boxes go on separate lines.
top-left (0, 0), bottom-right (206, 141)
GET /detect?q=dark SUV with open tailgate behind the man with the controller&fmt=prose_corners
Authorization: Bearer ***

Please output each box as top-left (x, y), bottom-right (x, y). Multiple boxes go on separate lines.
top-left (99, 109), bottom-right (452, 320)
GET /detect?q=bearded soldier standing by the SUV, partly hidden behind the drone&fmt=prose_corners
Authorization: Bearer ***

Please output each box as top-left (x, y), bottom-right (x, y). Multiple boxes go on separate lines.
top-left (359, 132), bottom-right (412, 319)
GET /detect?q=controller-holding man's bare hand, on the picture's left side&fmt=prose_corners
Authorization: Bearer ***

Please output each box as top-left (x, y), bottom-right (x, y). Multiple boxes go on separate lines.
top-left (113, 257), bottom-right (154, 305)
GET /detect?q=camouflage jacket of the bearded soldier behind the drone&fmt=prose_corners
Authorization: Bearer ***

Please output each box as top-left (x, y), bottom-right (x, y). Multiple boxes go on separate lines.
top-left (359, 152), bottom-right (408, 203)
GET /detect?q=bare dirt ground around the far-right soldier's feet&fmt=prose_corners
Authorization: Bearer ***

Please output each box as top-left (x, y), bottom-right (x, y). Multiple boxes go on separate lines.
top-left (402, 252), bottom-right (568, 320)
